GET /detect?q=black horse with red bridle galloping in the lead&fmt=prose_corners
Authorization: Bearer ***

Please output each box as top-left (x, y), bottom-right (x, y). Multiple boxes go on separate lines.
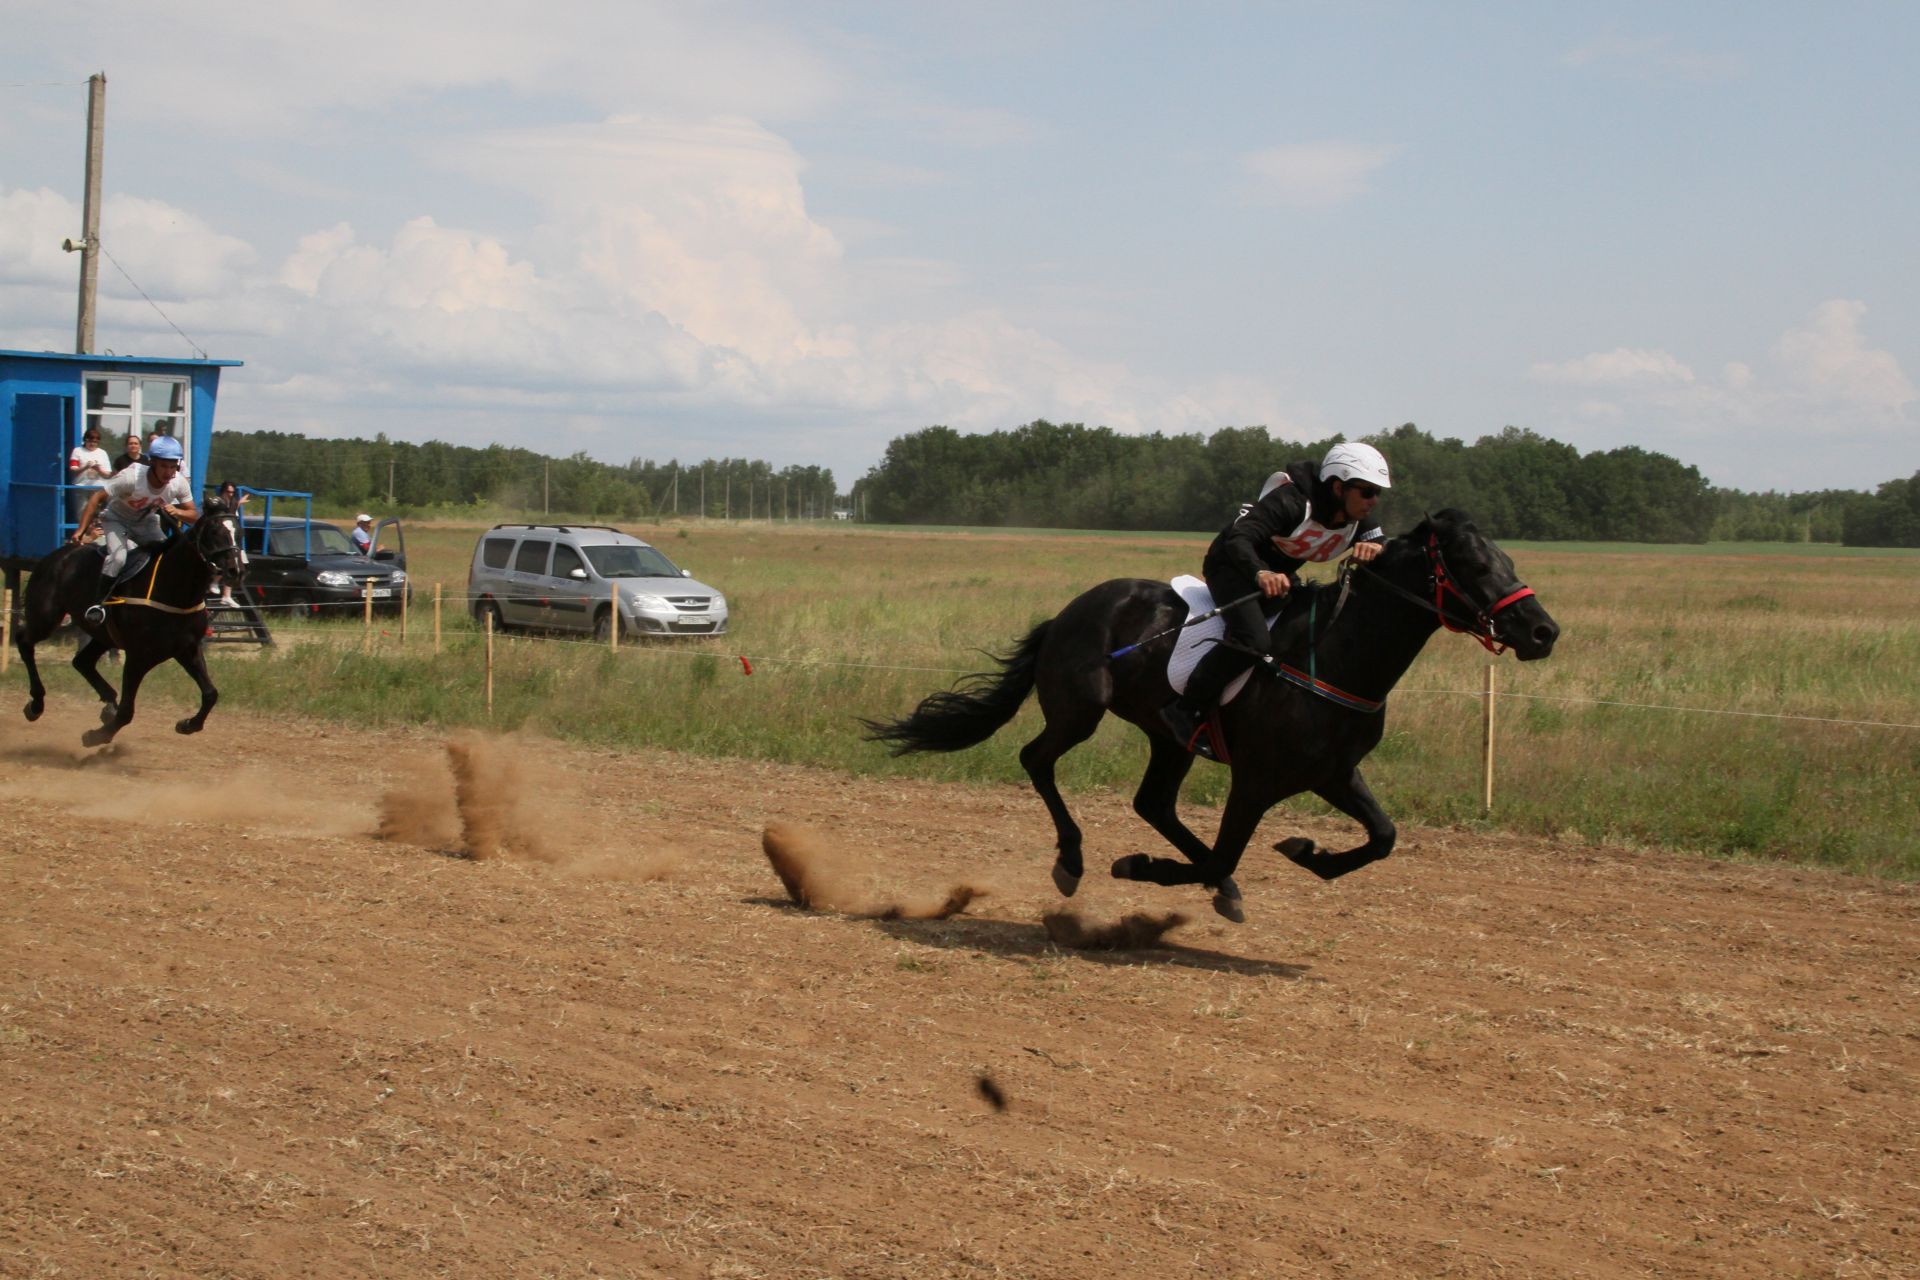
top-left (862, 510), bottom-right (1559, 921)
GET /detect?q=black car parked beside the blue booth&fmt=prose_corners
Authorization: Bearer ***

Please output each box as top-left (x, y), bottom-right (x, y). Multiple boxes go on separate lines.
top-left (240, 516), bottom-right (413, 614)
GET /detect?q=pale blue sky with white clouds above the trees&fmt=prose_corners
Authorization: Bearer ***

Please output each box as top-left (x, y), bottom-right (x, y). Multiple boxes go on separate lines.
top-left (0, 0), bottom-right (1920, 491)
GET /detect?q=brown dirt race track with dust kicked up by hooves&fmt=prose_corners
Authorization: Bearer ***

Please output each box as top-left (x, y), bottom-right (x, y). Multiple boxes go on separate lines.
top-left (0, 699), bottom-right (1920, 1280)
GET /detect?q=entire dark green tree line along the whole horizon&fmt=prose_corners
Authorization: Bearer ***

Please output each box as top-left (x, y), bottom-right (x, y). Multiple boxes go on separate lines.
top-left (207, 420), bottom-right (1920, 547)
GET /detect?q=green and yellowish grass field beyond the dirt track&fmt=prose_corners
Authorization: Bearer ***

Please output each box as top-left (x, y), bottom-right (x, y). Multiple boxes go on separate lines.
top-left (10, 522), bottom-right (1920, 877)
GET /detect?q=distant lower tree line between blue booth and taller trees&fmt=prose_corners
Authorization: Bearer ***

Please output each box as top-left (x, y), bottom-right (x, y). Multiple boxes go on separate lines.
top-left (207, 432), bottom-right (835, 520)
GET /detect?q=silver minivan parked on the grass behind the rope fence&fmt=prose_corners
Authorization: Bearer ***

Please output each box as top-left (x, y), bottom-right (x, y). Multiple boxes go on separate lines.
top-left (467, 524), bottom-right (728, 641)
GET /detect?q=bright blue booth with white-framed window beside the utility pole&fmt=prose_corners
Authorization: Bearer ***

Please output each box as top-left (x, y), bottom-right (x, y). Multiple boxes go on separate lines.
top-left (0, 349), bottom-right (240, 593)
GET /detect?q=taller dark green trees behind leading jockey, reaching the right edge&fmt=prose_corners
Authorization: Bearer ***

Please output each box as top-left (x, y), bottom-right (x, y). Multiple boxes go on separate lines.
top-left (854, 420), bottom-right (1920, 547)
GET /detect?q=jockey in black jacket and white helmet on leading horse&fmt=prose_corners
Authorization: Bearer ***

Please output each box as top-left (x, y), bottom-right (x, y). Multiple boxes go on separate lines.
top-left (1160, 443), bottom-right (1388, 758)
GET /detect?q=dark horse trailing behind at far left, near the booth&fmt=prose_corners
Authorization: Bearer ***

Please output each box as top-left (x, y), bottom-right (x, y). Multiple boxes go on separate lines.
top-left (13, 501), bottom-right (246, 747)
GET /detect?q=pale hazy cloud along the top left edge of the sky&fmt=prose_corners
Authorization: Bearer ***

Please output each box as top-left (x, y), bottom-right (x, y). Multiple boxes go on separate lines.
top-left (10, 0), bottom-right (841, 136)
